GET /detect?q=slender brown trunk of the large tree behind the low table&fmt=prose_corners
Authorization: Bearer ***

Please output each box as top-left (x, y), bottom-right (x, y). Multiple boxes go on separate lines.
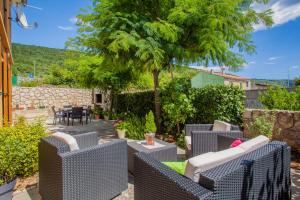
top-left (152, 70), bottom-right (161, 133)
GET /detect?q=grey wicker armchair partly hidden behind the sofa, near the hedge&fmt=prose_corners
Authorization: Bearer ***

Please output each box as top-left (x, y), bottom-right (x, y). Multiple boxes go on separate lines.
top-left (185, 124), bottom-right (243, 157)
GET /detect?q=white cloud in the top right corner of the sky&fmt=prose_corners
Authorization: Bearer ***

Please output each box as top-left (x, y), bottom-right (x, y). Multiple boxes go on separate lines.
top-left (253, 0), bottom-right (300, 30)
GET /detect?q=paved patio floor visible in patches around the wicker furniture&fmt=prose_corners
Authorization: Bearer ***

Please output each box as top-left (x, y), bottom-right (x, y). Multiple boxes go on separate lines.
top-left (13, 120), bottom-right (300, 200)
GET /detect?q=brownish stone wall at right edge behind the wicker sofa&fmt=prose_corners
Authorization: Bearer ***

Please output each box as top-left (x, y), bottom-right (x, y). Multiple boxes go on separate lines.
top-left (244, 109), bottom-right (300, 153)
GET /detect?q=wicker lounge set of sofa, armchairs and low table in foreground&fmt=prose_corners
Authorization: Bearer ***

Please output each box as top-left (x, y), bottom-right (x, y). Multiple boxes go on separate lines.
top-left (39, 121), bottom-right (291, 200)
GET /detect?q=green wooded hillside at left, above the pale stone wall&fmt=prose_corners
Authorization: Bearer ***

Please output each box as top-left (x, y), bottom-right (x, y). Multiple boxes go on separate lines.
top-left (12, 43), bottom-right (67, 76)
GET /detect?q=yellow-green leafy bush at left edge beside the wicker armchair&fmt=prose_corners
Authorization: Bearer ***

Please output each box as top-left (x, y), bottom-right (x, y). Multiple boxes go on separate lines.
top-left (0, 118), bottom-right (46, 185)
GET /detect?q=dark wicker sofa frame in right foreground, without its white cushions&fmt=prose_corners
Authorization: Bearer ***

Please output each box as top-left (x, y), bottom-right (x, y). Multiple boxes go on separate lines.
top-left (134, 136), bottom-right (291, 200)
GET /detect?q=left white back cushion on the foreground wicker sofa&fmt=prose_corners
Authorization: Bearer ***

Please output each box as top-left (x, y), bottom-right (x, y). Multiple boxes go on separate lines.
top-left (184, 147), bottom-right (245, 183)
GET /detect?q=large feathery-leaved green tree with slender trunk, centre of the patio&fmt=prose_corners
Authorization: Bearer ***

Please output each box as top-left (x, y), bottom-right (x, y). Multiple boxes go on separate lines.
top-left (68, 0), bottom-right (272, 130)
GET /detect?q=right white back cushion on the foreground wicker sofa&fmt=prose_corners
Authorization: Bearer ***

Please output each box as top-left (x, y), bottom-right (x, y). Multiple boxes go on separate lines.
top-left (239, 135), bottom-right (270, 154)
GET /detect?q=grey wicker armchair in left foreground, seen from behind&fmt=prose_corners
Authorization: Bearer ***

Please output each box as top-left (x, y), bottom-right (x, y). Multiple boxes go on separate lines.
top-left (39, 133), bottom-right (128, 200)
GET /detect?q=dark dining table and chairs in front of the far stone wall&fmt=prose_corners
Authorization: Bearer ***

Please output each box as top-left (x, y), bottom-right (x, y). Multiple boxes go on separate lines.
top-left (52, 106), bottom-right (92, 126)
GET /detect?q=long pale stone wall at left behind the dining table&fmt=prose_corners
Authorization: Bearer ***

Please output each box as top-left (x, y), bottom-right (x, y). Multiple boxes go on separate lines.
top-left (12, 87), bottom-right (93, 110)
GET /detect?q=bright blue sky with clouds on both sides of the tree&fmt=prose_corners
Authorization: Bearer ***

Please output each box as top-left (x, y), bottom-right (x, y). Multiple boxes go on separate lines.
top-left (12, 0), bottom-right (300, 79)
